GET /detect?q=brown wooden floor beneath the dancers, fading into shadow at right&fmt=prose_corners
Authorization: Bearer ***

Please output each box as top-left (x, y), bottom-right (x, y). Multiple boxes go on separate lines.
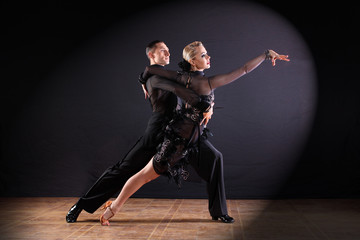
top-left (0, 198), bottom-right (360, 240)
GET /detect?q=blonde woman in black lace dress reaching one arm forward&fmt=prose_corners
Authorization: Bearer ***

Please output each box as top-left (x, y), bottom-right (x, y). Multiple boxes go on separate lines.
top-left (100, 41), bottom-right (289, 225)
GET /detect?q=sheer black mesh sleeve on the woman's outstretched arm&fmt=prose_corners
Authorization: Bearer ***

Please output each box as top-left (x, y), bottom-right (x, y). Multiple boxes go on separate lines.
top-left (209, 54), bottom-right (266, 89)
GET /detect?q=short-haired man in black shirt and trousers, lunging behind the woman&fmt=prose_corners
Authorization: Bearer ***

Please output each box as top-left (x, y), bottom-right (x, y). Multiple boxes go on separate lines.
top-left (66, 40), bottom-right (234, 223)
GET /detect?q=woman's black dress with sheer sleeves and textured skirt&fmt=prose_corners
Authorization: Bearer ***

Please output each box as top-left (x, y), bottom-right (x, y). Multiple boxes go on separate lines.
top-left (142, 54), bottom-right (266, 186)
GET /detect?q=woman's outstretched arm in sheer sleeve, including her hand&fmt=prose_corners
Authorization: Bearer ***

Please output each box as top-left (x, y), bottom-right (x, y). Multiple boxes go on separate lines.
top-left (209, 50), bottom-right (290, 89)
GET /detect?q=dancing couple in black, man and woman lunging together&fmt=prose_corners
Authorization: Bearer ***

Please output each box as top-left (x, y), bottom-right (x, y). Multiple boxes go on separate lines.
top-left (66, 41), bottom-right (289, 225)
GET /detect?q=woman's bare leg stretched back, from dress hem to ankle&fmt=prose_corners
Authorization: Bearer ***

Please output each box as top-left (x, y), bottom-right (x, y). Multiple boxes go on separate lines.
top-left (104, 159), bottom-right (160, 218)
